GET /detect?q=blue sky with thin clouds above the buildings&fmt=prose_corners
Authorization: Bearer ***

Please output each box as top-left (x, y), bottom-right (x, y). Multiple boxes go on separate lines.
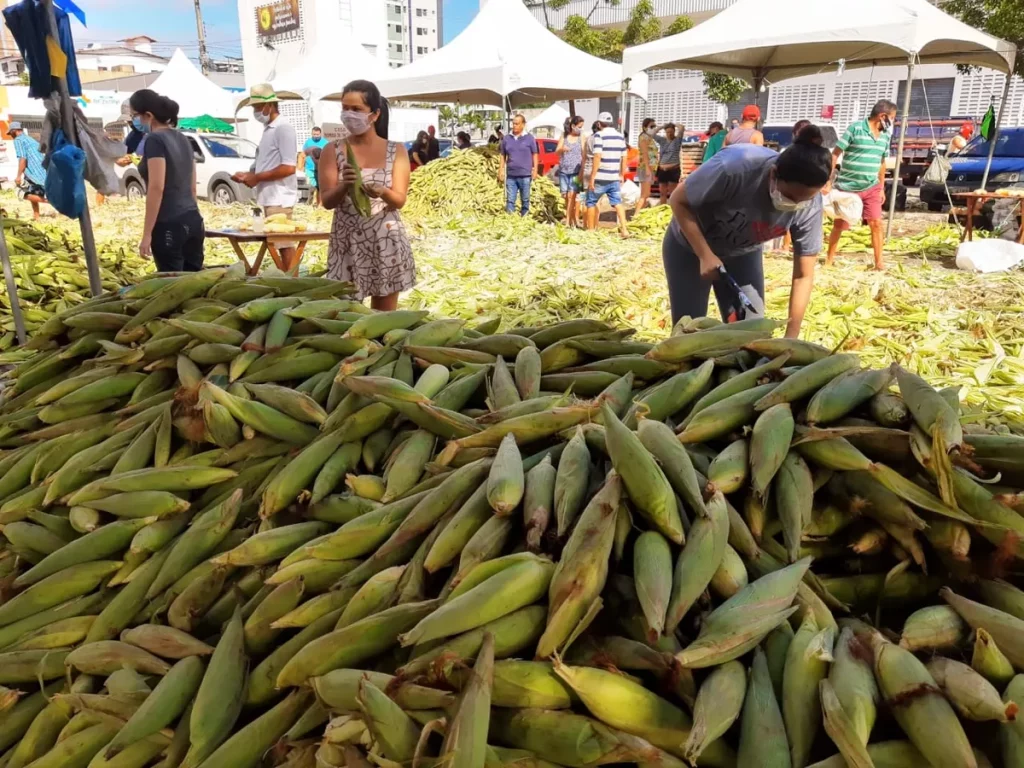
top-left (73, 0), bottom-right (479, 58)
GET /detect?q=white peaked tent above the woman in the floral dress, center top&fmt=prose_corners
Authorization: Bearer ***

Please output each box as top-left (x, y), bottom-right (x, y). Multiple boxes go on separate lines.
top-left (368, 0), bottom-right (647, 108)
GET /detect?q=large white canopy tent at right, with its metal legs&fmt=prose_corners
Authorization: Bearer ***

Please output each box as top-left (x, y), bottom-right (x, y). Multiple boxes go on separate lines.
top-left (623, 0), bottom-right (1016, 234)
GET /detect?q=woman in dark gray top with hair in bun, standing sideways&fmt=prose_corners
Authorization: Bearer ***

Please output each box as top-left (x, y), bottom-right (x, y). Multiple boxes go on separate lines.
top-left (128, 89), bottom-right (206, 272)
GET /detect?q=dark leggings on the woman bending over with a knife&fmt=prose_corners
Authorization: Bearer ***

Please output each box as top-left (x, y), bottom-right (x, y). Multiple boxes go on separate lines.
top-left (662, 228), bottom-right (765, 325)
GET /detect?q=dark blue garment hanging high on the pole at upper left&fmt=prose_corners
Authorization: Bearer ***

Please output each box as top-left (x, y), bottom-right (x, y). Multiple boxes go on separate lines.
top-left (3, 0), bottom-right (82, 98)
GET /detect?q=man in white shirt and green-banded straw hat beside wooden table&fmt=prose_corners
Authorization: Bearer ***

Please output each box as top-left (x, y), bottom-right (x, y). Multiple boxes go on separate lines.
top-left (232, 83), bottom-right (299, 265)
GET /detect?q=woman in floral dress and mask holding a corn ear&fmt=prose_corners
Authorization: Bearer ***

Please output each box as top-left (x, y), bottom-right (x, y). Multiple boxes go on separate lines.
top-left (319, 80), bottom-right (416, 311)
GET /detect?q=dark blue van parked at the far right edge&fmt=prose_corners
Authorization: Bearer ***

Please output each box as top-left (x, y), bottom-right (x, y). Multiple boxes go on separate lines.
top-left (921, 127), bottom-right (1024, 211)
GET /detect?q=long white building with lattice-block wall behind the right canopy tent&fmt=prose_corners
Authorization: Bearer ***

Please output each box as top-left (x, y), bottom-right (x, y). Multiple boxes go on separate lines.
top-left (530, 0), bottom-right (1024, 136)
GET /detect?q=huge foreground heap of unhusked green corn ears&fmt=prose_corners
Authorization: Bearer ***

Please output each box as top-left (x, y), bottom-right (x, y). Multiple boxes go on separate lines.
top-left (0, 266), bottom-right (1024, 768)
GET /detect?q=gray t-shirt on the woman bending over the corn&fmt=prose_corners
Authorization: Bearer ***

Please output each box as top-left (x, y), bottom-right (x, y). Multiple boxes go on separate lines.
top-left (671, 144), bottom-right (821, 260)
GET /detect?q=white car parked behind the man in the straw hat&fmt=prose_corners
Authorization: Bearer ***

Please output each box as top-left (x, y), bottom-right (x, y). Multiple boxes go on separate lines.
top-left (117, 131), bottom-right (309, 205)
